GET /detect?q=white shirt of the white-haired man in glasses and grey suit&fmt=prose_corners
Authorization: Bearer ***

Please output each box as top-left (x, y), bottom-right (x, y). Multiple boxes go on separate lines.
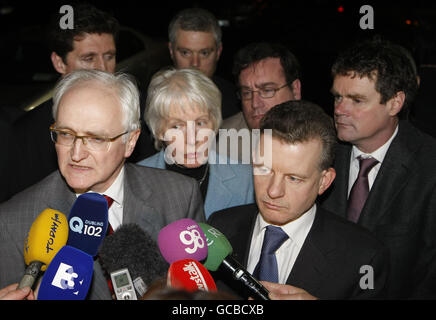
top-left (76, 166), bottom-right (124, 231)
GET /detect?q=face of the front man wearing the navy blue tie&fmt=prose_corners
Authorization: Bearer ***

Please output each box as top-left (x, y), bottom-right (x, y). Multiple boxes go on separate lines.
top-left (253, 135), bottom-right (335, 225)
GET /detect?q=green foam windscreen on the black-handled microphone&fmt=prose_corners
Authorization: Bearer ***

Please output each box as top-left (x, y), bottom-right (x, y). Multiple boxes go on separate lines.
top-left (199, 222), bottom-right (233, 271)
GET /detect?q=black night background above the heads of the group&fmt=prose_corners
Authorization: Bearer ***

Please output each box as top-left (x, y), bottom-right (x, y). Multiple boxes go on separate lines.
top-left (0, 0), bottom-right (436, 112)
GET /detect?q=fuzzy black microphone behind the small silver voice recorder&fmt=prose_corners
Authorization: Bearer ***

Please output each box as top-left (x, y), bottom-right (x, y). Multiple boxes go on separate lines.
top-left (99, 224), bottom-right (168, 296)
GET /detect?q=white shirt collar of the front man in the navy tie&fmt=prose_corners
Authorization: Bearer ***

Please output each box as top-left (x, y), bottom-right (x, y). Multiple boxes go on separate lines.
top-left (256, 204), bottom-right (316, 248)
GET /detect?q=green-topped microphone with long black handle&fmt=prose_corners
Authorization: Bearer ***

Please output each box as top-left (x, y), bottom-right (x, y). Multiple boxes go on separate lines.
top-left (199, 222), bottom-right (270, 300)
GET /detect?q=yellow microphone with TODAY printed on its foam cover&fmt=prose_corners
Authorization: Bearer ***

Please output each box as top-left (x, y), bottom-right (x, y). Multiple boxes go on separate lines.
top-left (18, 209), bottom-right (68, 288)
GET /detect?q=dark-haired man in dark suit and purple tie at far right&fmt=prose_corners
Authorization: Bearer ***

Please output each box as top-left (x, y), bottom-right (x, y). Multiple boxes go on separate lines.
top-left (322, 39), bottom-right (436, 299)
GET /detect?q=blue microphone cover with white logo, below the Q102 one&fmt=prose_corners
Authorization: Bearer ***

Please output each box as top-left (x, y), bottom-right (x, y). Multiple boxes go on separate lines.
top-left (37, 245), bottom-right (94, 300)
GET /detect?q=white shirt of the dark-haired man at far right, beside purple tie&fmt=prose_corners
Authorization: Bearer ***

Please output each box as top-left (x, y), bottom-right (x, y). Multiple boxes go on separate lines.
top-left (348, 125), bottom-right (398, 196)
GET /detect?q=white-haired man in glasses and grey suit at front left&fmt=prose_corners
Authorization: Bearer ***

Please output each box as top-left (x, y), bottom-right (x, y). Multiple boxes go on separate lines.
top-left (0, 70), bottom-right (205, 299)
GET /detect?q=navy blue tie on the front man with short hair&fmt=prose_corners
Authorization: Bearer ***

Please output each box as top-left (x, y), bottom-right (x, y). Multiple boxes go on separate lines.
top-left (253, 226), bottom-right (289, 283)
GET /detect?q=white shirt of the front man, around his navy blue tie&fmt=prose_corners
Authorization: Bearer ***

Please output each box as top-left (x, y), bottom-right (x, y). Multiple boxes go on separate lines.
top-left (247, 204), bottom-right (316, 283)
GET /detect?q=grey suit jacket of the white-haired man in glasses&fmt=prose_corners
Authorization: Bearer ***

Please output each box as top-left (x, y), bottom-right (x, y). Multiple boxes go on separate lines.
top-left (0, 164), bottom-right (205, 299)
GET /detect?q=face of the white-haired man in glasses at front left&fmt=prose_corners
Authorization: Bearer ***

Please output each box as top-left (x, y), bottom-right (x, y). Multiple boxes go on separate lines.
top-left (56, 83), bottom-right (139, 193)
